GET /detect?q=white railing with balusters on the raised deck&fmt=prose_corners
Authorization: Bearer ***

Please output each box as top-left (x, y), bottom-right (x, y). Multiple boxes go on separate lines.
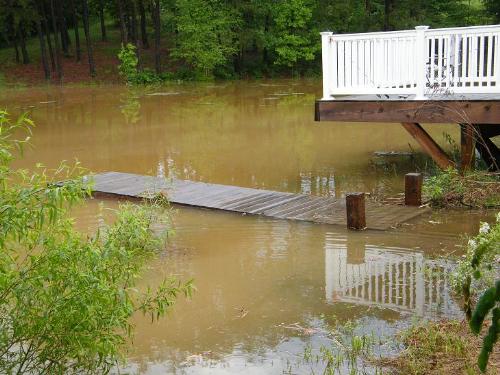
top-left (321, 25), bottom-right (500, 100)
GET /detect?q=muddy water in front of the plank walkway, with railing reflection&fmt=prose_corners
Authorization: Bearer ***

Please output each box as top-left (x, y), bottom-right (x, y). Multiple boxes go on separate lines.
top-left (110, 209), bottom-right (460, 374)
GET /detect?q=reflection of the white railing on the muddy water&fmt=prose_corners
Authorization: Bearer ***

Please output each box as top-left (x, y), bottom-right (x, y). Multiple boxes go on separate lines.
top-left (325, 242), bottom-right (459, 317)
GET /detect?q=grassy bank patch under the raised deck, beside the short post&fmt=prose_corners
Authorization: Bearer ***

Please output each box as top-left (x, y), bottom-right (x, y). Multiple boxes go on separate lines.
top-left (424, 168), bottom-right (500, 208)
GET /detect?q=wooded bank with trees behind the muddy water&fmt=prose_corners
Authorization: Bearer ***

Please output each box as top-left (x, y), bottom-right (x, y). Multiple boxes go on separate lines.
top-left (0, 0), bottom-right (500, 81)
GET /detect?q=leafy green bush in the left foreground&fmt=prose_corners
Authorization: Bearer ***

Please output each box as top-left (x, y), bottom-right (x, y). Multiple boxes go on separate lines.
top-left (0, 111), bottom-right (192, 374)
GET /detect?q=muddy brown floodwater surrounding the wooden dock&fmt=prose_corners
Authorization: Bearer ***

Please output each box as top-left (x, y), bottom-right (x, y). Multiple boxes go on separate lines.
top-left (0, 80), bottom-right (492, 374)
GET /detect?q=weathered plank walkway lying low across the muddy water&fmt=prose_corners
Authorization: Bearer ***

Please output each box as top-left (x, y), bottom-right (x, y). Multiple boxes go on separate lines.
top-left (89, 172), bottom-right (428, 230)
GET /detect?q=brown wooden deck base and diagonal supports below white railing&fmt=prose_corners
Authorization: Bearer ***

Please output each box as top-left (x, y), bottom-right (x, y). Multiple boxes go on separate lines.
top-left (315, 94), bottom-right (500, 170)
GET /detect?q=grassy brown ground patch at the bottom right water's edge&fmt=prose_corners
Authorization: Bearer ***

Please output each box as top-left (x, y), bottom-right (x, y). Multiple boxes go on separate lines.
top-left (377, 320), bottom-right (500, 375)
